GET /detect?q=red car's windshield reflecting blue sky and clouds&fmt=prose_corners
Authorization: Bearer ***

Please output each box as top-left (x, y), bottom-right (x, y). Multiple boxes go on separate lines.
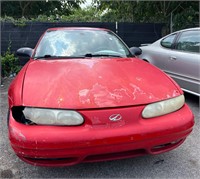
top-left (34, 29), bottom-right (131, 58)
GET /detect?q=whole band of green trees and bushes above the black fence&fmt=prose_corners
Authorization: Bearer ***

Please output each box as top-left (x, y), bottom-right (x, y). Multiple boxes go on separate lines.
top-left (0, 0), bottom-right (200, 31)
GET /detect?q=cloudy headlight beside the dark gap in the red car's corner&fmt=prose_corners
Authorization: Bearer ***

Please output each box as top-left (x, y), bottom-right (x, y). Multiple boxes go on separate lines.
top-left (23, 107), bottom-right (84, 126)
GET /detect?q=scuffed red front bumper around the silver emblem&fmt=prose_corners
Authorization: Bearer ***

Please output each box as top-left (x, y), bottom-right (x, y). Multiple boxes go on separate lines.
top-left (9, 105), bottom-right (194, 166)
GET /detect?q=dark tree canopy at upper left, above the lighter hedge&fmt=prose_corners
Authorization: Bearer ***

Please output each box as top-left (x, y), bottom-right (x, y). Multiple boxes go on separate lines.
top-left (1, 0), bottom-right (85, 18)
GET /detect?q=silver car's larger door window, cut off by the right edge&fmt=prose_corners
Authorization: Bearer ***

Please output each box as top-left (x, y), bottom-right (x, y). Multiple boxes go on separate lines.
top-left (177, 30), bottom-right (200, 53)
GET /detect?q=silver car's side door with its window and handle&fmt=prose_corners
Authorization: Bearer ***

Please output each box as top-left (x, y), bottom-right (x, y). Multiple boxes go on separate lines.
top-left (161, 30), bottom-right (200, 93)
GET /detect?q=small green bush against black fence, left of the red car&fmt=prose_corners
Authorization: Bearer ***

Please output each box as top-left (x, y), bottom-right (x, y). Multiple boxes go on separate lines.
top-left (0, 45), bottom-right (21, 77)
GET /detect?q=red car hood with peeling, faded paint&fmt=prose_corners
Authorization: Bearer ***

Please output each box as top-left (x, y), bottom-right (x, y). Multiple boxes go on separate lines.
top-left (22, 58), bottom-right (180, 109)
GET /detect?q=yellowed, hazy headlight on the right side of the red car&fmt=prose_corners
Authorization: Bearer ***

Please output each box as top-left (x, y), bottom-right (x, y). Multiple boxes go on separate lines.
top-left (142, 95), bottom-right (185, 118)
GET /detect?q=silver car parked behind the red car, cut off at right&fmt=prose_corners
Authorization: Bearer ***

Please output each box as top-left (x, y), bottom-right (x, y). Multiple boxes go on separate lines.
top-left (139, 27), bottom-right (200, 96)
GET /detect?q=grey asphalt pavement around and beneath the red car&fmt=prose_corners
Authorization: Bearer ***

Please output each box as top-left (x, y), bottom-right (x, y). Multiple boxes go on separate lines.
top-left (0, 78), bottom-right (200, 179)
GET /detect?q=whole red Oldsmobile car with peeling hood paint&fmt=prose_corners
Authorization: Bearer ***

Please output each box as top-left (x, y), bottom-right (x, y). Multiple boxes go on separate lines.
top-left (8, 28), bottom-right (194, 166)
